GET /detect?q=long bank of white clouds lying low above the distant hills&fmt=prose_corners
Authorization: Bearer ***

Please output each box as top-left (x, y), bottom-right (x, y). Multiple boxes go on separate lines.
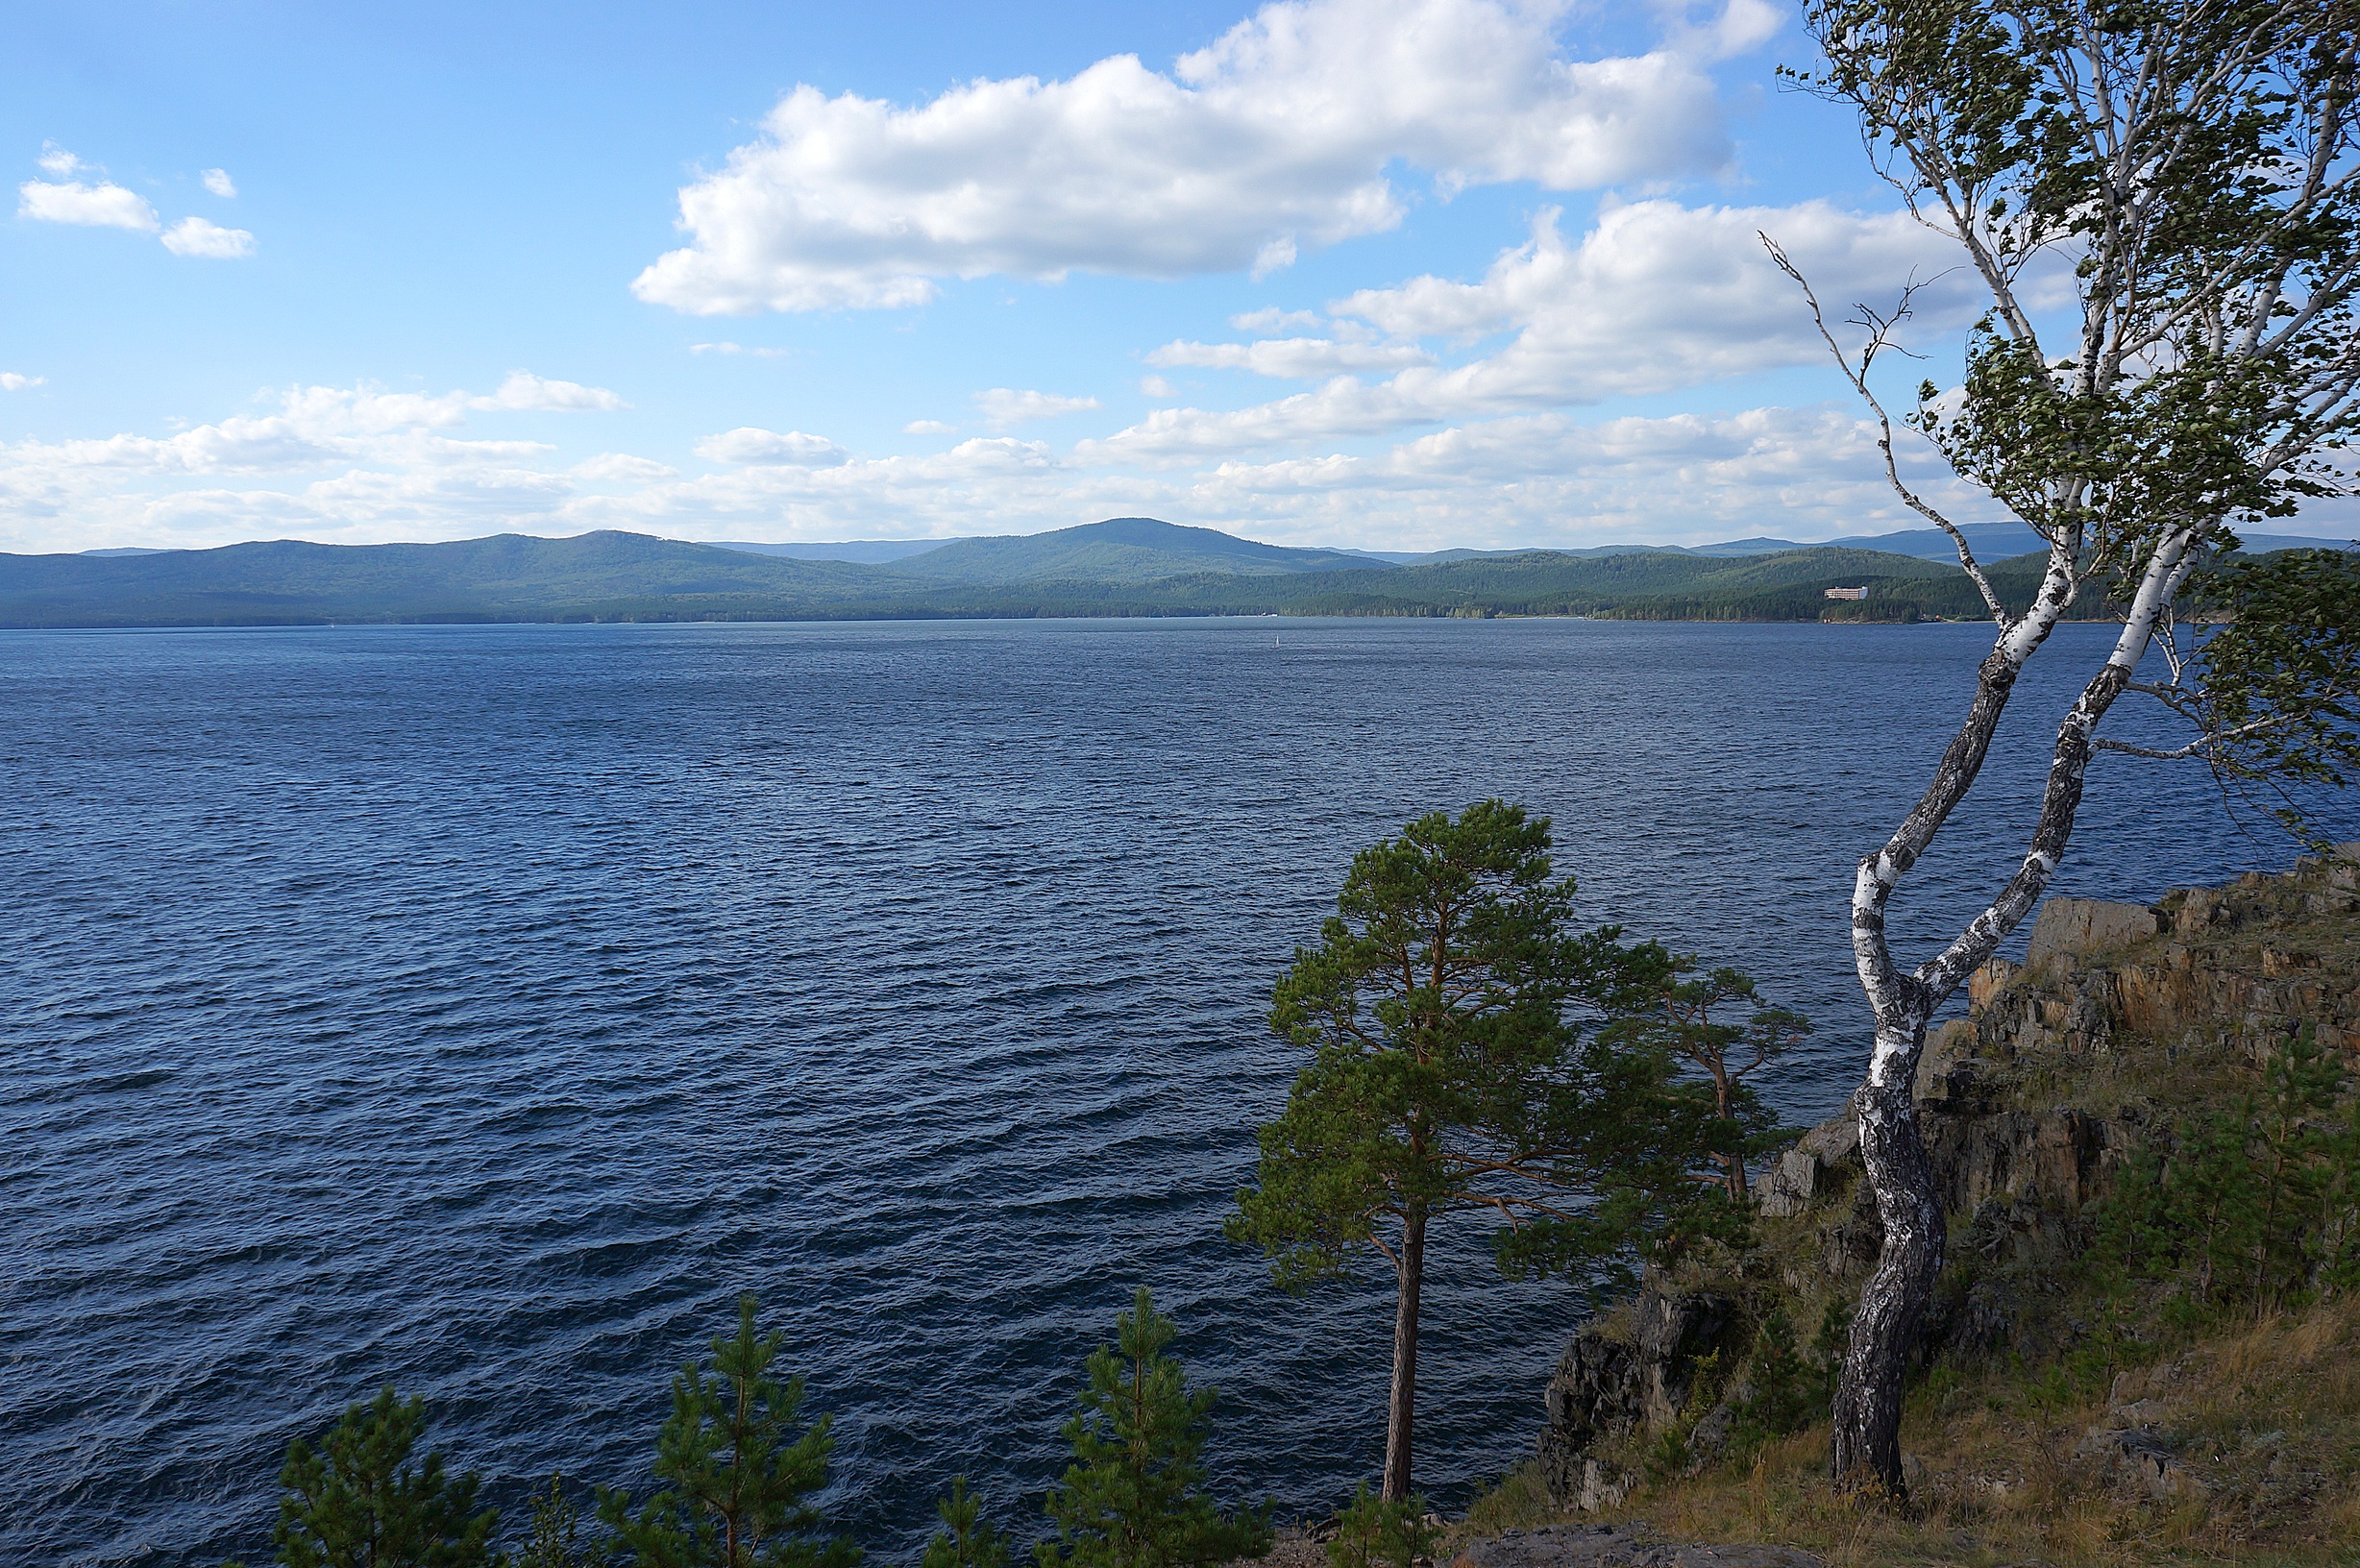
top-left (0, 184), bottom-right (2114, 551)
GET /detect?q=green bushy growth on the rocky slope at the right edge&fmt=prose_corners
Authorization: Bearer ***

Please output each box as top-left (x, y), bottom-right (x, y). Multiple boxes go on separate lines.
top-left (2098, 1025), bottom-right (2360, 1313)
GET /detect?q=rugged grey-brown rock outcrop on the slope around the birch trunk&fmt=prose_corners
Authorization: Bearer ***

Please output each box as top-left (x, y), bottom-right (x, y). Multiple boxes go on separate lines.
top-left (1529, 843), bottom-right (2360, 1511)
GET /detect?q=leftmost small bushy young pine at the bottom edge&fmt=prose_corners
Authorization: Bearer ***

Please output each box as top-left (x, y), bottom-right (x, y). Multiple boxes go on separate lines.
top-left (244, 1388), bottom-right (501, 1568)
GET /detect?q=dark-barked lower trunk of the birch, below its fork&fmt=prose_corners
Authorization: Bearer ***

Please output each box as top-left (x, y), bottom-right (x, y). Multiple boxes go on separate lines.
top-left (1833, 1022), bottom-right (1942, 1497)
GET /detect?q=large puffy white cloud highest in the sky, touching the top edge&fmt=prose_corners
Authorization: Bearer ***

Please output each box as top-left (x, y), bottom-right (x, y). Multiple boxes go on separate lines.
top-left (632, 0), bottom-right (1760, 314)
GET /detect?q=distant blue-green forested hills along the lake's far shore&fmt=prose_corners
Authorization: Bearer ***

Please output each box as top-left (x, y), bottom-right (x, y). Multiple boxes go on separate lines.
top-left (0, 517), bottom-right (2320, 625)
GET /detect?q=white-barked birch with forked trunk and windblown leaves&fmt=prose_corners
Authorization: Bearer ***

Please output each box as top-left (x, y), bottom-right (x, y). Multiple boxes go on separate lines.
top-left (1765, 0), bottom-right (2360, 1490)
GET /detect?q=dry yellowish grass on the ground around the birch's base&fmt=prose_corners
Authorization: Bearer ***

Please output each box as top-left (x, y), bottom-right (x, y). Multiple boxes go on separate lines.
top-left (1463, 1304), bottom-right (2360, 1568)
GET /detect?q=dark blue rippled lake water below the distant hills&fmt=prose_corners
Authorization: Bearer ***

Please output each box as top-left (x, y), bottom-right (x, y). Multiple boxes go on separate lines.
top-left (0, 619), bottom-right (2322, 1563)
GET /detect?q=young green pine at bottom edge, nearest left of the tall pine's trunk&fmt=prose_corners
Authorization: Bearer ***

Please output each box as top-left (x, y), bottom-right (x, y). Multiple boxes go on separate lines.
top-left (1034, 1287), bottom-right (1269, 1568)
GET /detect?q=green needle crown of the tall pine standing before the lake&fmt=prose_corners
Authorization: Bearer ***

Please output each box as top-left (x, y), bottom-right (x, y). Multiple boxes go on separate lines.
top-left (1230, 800), bottom-right (1692, 1289)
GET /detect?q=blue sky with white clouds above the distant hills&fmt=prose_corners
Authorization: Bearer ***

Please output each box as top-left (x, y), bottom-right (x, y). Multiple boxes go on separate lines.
top-left (0, 0), bottom-right (2332, 552)
